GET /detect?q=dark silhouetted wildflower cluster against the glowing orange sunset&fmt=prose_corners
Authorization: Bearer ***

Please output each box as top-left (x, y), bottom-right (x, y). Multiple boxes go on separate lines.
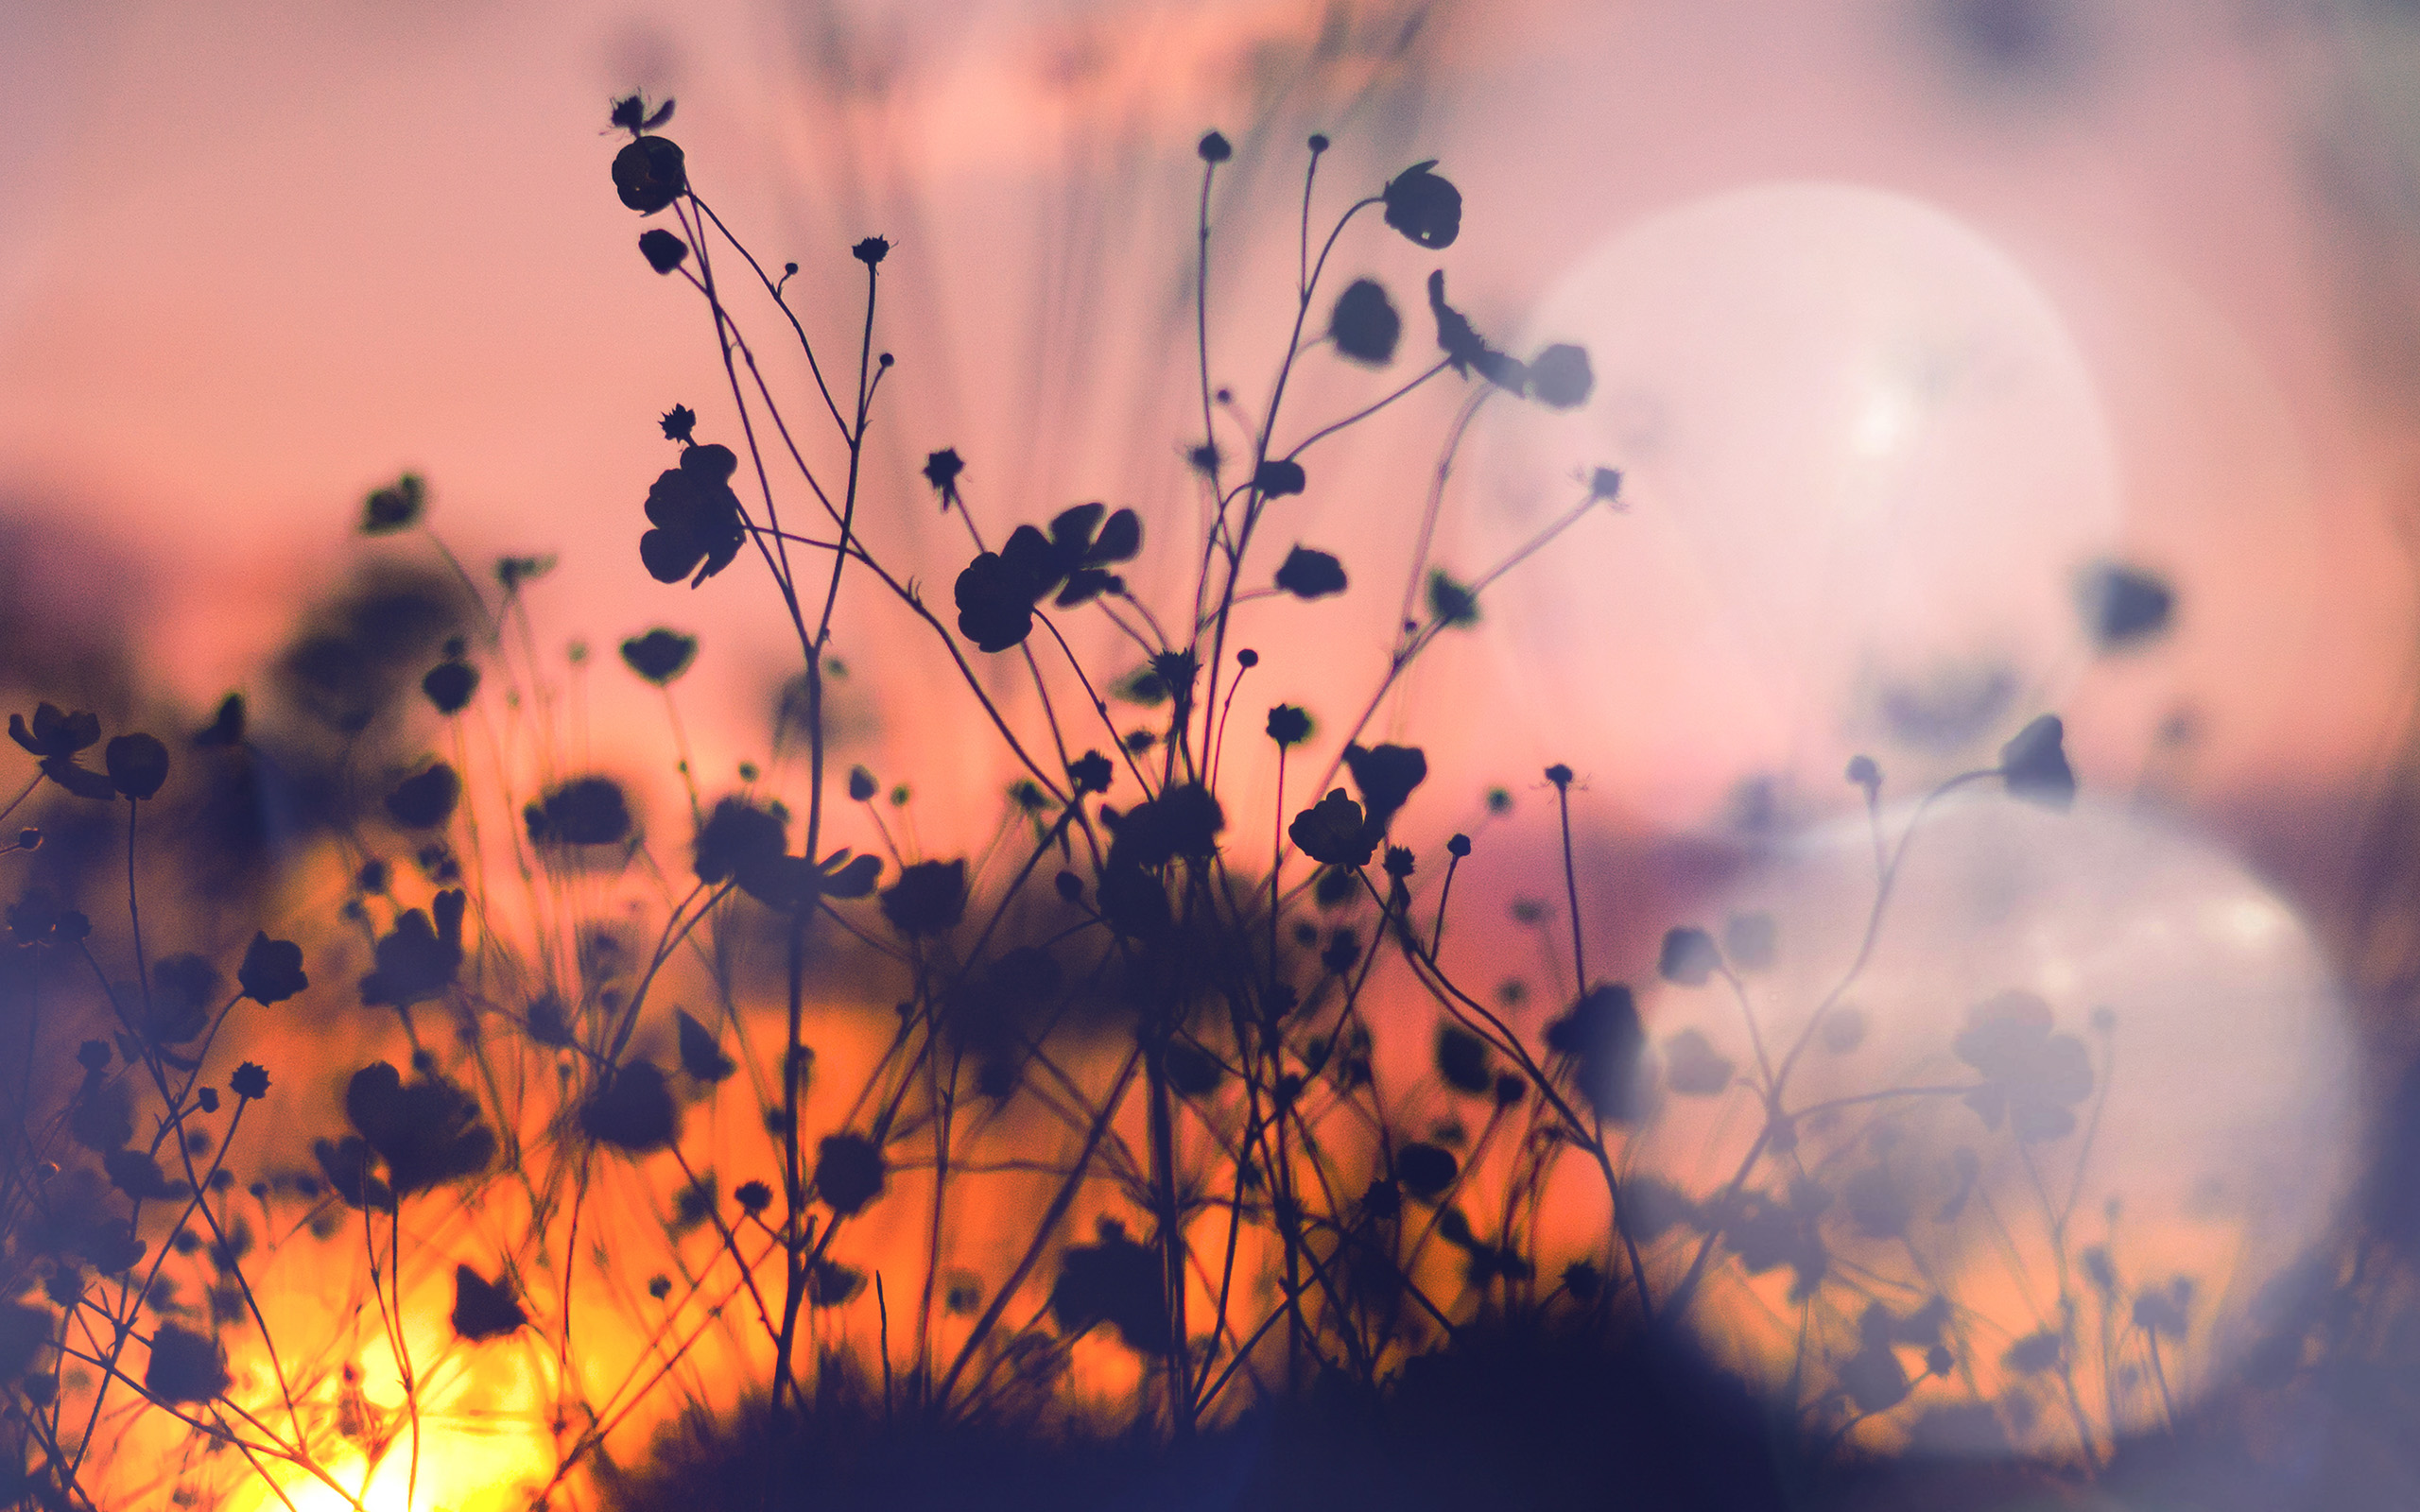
top-left (0, 85), bottom-right (2400, 1512)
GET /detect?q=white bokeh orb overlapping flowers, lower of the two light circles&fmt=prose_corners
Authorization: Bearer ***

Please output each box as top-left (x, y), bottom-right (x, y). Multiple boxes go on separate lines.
top-left (1629, 791), bottom-right (2360, 1452)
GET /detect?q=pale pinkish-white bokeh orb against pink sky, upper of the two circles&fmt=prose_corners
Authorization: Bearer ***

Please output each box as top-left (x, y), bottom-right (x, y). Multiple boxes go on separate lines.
top-left (1461, 184), bottom-right (2120, 822)
